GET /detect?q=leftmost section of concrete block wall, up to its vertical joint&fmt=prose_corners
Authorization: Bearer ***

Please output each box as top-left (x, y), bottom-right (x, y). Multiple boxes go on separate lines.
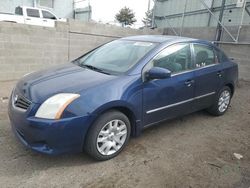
top-left (0, 23), bottom-right (68, 80)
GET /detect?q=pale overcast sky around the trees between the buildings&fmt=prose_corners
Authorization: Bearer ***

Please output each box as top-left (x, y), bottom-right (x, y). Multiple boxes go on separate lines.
top-left (75, 0), bottom-right (153, 27)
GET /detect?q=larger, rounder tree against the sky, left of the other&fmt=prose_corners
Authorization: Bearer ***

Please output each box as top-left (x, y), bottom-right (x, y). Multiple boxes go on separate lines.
top-left (115, 7), bottom-right (136, 26)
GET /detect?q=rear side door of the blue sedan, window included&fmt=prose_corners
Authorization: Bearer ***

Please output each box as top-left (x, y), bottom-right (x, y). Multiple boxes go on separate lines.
top-left (192, 43), bottom-right (224, 110)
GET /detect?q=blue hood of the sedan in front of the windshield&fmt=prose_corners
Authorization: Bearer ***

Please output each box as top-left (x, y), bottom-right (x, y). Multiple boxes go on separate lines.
top-left (16, 63), bottom-right (116, 103)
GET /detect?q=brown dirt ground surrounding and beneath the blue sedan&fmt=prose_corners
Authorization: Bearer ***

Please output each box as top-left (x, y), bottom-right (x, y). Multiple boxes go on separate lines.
top-left (0, 81), bottom-right (250, 188)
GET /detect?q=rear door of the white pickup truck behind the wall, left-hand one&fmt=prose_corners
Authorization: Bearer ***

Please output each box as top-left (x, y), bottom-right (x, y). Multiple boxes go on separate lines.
top-left (25, 8), bottom-right (43, 25)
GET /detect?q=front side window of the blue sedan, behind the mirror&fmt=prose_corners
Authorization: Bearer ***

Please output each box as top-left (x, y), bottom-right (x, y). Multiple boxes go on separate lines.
top-left (151, 43), bottom-right (192, 73)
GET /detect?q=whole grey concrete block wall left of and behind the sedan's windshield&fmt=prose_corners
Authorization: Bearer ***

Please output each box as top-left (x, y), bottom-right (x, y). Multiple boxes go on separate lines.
top-left (0, 20), bottom-right (161, 81)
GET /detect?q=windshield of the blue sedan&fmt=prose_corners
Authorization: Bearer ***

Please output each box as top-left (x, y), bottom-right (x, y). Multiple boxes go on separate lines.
top-left (74, 40), bottom-right (156, 74)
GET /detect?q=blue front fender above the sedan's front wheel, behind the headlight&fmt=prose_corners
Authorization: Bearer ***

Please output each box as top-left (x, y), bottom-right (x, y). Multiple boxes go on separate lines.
top-left (64, 76), bottom-right (142, 119)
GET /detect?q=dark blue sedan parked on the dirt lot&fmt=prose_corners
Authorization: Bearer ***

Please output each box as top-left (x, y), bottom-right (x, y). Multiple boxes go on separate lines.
top-left (9, 36), bottom-right (238, 160)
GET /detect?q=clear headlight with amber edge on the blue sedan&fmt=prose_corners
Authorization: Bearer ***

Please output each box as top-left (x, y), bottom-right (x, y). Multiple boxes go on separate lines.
top-left (35, 93), bottom-right (80, 119)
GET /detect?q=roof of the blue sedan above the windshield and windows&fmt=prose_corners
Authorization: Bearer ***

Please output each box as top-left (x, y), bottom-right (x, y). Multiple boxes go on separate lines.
top-left (122, 35), bottom-right (198, 43)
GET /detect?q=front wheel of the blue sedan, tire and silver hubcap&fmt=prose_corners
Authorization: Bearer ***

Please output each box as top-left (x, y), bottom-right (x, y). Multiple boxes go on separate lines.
top-left (84, 110), bottom-right (131, 161)
